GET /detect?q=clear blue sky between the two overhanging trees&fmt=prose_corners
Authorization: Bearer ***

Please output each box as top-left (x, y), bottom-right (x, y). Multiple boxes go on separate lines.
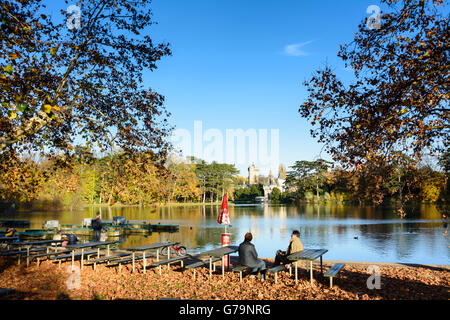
top-left (145, 0), bottom-right (383, 175)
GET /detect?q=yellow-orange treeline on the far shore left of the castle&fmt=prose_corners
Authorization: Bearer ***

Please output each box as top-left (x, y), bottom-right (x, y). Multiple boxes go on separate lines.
top-left (0, 150), bottom-right (243, 209)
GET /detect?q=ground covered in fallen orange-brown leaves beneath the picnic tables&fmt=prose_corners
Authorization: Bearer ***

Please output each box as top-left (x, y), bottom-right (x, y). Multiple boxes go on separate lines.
top-left (0, 259), bottom-right (450, 300)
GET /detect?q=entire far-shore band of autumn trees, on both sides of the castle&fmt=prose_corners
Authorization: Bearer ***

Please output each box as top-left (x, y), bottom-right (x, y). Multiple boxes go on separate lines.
top-left (0, 151), bottom-right (449, 210)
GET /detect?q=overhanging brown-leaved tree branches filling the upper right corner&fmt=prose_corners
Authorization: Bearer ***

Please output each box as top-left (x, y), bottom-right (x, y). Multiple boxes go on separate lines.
top-left (299, 0), bottom-right (450, 167)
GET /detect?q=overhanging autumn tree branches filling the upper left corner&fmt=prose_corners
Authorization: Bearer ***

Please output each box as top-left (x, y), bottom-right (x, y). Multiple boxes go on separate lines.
top-left (0, 0), bottom-right (170, 158)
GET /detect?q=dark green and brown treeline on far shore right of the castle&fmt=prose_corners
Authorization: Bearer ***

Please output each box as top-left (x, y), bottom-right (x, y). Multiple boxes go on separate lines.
top-left (286, 155), bottom-right (449, 211)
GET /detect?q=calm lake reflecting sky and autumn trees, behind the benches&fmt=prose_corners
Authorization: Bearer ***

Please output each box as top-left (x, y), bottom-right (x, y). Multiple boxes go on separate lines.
top-left (2, 204), bottom-right (450, 265)
